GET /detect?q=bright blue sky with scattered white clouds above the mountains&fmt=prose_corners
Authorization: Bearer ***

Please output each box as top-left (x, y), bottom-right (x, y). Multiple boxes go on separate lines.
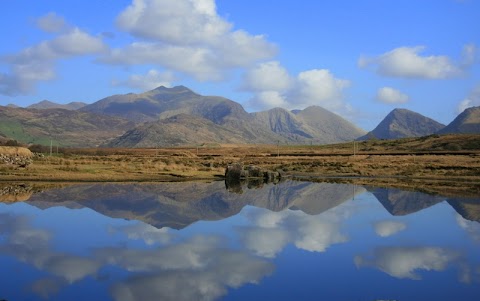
top-left (0, 0), bottom-right (480, 130)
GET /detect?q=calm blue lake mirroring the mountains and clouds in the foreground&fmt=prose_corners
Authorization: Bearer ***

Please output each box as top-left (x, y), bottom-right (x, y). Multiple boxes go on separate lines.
top-left (0, 181), bottom-right (480, 301)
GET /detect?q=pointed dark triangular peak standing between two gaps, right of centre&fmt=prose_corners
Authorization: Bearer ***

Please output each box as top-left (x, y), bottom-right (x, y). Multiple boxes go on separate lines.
top-left (360, 109), bottom-right (445, 140)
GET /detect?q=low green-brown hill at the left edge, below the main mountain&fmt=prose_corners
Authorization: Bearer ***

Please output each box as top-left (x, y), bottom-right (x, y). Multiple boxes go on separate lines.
top-left (0, 106), bottom-right (134, 147)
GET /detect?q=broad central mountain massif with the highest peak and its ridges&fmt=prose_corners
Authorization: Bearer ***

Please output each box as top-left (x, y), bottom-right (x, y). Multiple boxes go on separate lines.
top-left (86, 86), bottom-right (365, 147)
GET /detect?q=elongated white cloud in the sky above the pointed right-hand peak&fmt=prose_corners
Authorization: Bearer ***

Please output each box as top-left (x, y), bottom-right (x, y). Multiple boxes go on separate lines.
top-left (358, 46), bottom-right (462, 79)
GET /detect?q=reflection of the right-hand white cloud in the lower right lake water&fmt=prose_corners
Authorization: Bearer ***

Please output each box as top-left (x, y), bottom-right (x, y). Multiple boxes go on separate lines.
top-left (355, 247), bottom-right (458, 280)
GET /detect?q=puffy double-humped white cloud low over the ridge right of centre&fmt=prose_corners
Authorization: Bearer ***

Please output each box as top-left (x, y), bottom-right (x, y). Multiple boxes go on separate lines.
top-left (242, 61), bottom-right (350, 111)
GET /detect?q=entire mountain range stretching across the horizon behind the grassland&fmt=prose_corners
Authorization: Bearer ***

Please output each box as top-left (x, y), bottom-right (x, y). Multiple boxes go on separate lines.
top-left (0, 86), bottom-right (480, 147)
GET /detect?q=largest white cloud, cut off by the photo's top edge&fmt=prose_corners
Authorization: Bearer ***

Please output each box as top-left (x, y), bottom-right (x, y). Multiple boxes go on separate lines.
top-left (99, 0), bottom-right (276, 81)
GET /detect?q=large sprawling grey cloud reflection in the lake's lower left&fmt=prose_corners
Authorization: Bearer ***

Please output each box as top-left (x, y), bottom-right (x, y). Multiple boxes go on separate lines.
top-left (0, 210), bottom-right (274, 301)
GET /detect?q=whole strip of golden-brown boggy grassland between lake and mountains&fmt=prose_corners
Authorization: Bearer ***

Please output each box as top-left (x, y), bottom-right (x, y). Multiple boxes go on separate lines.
top-left (0, 135), bottom-right (480, 195)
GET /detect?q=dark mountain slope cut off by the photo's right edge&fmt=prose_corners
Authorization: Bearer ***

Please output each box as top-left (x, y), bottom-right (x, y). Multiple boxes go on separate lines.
top-left (438, 107), bottom-right (480, 134)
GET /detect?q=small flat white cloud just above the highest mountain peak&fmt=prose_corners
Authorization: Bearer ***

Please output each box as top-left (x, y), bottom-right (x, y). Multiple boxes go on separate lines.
top-left (112, 69), bottom-right (175, 91)
